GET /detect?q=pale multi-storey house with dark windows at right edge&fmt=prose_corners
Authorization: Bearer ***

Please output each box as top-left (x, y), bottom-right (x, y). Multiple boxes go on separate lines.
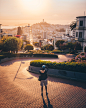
top-left (75, 16), bottom-right (86, 51)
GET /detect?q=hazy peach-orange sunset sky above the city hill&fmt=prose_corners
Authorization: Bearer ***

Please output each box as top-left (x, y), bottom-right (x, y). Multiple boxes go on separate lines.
top-left (0, 0), bottom-right (86, 25)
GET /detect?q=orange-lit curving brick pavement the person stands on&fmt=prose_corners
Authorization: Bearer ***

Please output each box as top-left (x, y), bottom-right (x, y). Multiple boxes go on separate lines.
top-left (0, 59), bottom-right (86, 108)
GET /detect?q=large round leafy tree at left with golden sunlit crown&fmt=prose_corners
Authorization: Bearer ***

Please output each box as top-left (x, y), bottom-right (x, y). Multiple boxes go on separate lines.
top-left (4, 37), bottom-right (22, 53)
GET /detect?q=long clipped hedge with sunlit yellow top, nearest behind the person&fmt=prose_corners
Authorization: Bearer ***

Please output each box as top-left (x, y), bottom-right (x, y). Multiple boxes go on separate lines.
top-left (30, 60), bottom-right (86, 73)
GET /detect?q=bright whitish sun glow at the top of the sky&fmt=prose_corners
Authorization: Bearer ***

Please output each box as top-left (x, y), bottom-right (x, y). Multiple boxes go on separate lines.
top-left (21, 0), bottom-right (45, 14)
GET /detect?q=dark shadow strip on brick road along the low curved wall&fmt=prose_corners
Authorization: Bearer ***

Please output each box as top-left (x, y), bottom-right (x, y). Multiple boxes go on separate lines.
top-left (29, 72), bottom-right (86, 89)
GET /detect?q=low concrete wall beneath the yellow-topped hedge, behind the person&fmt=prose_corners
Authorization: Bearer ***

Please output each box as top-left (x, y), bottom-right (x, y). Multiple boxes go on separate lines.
top-left (27, 66), bottom-right (86, 82)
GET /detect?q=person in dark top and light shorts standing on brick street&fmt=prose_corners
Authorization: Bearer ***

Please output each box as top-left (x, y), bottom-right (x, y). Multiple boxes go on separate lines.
top-left (39, 65), bottom-right (48, 96)
